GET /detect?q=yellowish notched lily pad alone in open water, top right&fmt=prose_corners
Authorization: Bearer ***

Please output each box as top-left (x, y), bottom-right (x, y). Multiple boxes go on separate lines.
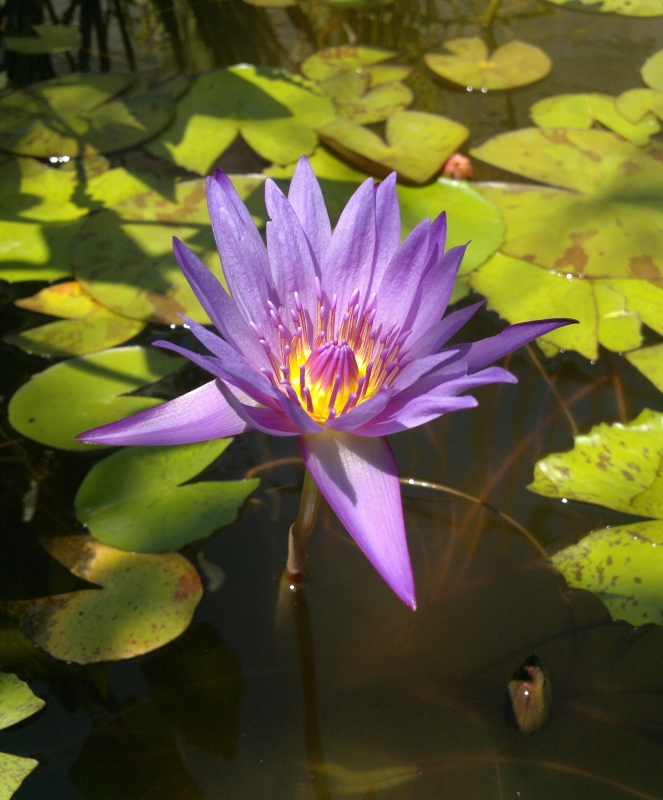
top-left (424, 38), bottom-right (552, 90)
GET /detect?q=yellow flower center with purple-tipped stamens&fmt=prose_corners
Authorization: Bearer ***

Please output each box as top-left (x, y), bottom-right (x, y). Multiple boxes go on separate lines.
top-left (251, 278), bottom-right (410, 424)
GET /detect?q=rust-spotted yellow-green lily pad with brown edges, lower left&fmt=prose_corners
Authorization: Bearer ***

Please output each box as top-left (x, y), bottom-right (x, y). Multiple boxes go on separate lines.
top-left (2, 536), bottom-right (203, 664)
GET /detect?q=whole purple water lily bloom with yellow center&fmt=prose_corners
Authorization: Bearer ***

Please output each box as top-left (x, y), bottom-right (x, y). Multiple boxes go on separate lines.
top-left (77, 157), bottom-right (575, 608)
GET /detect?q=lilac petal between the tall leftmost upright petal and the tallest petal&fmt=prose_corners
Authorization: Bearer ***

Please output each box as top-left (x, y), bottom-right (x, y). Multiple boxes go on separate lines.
top-left (265, 178), bottom-right (316, 322)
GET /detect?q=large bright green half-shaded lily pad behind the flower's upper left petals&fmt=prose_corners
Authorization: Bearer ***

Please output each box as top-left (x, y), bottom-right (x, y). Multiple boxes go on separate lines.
top-left (147, 64), bottom-right (335, 175)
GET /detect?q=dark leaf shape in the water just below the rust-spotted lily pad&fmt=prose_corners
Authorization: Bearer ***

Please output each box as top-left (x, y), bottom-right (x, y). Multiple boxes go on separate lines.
top-left (140, 622), bottom-right (242, 761)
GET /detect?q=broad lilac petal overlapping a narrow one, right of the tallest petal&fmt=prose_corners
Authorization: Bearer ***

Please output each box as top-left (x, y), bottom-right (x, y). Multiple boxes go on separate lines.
top-left (322, 178), bottom-right (375, 326)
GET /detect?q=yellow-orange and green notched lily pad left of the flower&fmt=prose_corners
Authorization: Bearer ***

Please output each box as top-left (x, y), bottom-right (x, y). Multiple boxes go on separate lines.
top-left (3, 281), bottom-right (145, 356)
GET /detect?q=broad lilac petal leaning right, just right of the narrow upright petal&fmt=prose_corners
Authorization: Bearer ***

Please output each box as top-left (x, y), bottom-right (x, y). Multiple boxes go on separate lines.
top-left (375, 219), bottom-right (430, 330)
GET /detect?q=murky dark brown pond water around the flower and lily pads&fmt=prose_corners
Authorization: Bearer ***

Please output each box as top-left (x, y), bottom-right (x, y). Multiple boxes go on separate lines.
top-left (0, 0), bottom-right (663, 800)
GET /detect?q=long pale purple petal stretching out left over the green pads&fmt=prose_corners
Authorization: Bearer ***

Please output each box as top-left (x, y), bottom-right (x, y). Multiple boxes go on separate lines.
top-left (76, 381), bottom-right (249, 445)
